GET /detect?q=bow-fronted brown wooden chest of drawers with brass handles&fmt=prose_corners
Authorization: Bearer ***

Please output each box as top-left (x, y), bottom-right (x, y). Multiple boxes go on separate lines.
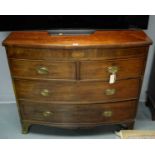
top-left (3, 30), bottom-right (151, 133)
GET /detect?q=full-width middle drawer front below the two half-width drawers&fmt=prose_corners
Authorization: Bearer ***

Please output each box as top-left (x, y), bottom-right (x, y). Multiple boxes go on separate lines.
top-left (15, 79), bottom-right (140, 103)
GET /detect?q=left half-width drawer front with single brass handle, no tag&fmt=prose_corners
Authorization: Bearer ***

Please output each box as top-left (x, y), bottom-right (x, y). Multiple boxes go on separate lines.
top-left (9, 59), bottom-right (76, 79)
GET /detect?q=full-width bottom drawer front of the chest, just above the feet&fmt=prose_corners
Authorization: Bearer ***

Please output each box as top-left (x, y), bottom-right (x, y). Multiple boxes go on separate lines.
top-left (19, 100), bottom-right (136, 123)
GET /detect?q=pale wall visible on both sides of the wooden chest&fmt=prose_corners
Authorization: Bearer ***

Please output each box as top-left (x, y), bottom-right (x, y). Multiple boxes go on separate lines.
top-left (0, 16), bottom-right (155, 103)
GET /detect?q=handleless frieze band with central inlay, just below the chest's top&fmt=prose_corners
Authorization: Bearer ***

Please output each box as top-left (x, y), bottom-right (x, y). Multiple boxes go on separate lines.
top-left (7, 47), bottom-right (148, 60)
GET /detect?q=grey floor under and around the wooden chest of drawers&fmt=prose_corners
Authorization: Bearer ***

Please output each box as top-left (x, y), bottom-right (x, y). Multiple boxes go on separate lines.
top-left (0, 103), bottom-right (155, 139)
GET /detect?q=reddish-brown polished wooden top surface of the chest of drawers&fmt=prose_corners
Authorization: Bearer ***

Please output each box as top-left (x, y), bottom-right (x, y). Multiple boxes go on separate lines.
top-left (3, 30), bottom-right (152, 48)
